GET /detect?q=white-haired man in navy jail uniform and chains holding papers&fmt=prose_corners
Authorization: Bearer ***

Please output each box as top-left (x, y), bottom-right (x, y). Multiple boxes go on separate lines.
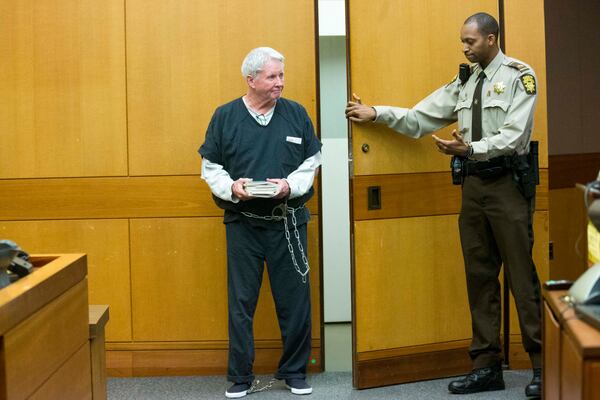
top-left (199, 47), bottom-right (321, 398)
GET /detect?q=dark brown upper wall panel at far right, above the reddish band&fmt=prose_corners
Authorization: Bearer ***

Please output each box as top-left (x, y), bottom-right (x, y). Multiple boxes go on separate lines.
top-left (544, 0), bottom-right (600, 155)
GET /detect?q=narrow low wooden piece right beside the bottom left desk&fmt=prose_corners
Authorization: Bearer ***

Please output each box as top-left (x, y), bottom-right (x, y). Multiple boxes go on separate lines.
top-left (89, 305), bottom-right (108, 400)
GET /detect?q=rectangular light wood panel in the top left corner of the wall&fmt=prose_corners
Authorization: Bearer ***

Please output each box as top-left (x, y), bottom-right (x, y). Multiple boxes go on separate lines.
top-left (0, 0), bottom-right (127, 178)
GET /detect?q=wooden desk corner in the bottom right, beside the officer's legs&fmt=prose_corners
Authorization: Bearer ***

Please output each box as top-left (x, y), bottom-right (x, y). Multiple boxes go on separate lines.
top-left (543, 290), bottom-right (600, 400)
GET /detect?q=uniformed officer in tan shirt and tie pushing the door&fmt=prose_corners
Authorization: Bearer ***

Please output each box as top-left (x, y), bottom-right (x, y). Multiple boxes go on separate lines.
top-left (346, 13), bottom-right (541, 396)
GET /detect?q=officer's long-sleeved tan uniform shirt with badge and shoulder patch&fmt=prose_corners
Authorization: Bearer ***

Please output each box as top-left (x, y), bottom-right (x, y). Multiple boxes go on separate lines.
top-left (374, 51), bottom-right (537, 160)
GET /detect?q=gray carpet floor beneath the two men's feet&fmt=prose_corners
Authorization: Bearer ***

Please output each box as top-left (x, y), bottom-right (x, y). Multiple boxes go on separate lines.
top-left (108, 370), bottom-right (532, 400)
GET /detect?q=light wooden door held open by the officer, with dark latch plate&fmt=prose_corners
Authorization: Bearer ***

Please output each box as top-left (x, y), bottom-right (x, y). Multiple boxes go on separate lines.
top-left (347, 0), bottom-right (547, 388)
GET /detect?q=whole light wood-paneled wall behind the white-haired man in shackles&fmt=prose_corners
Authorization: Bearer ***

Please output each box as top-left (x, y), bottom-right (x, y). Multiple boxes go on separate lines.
top-left (0, 0), bottom-right (321, 375)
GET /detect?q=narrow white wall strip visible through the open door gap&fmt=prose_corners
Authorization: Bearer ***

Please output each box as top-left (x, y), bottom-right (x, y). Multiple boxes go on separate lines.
top-left (319, 0), bottom-right (352, 323)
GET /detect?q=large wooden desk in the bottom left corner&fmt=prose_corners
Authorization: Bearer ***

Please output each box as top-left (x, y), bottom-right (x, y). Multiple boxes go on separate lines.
top-left (0, 254), bottom-right (92, 400)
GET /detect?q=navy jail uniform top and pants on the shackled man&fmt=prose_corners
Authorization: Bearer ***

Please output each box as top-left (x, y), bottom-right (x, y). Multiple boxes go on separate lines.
top-left (199, 98), bottom-right (321, 383)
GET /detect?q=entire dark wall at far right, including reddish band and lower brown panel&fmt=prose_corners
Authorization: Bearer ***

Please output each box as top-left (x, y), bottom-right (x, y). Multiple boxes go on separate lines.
top-left (544, 0), bottom-right (600, 280)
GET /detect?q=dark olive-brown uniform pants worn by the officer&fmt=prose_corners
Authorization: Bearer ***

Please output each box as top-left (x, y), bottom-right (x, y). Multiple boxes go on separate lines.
top-left (459, 173), bottom-right (541, 368)
